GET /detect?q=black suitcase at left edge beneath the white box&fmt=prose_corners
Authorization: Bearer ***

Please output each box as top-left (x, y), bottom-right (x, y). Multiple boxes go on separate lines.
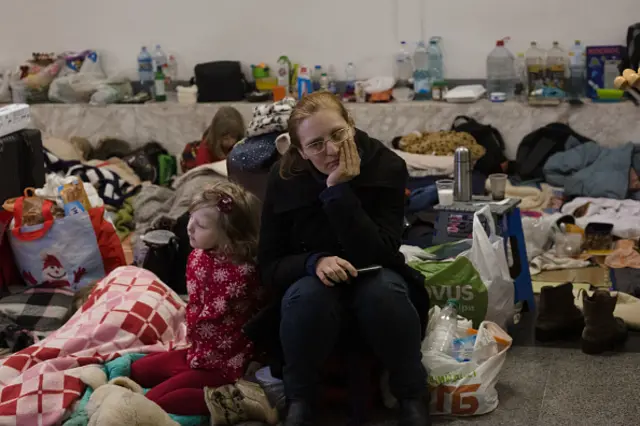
top-left (0, 129), bottom-right (44, 205)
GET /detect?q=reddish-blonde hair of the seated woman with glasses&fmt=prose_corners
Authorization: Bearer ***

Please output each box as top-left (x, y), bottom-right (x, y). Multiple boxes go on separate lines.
top-left (280, 92), bottom-right (354, 179)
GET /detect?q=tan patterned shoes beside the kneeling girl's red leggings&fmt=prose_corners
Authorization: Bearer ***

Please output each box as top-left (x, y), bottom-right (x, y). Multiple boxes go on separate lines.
top-left (204, 379), bottom-right (278, 426)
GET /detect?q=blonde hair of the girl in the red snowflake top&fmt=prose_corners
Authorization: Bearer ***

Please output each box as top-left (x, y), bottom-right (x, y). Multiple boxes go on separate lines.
top-left (189, 180), bottom-right (261, 263)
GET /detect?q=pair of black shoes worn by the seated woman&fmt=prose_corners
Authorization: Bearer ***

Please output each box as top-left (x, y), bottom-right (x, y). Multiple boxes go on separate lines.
top-left (284, 398), bottom-right (431, 426)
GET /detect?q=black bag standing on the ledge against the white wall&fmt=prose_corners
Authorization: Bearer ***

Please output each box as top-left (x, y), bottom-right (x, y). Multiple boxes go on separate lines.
top-left (194, 61), bottom-right (249, 102)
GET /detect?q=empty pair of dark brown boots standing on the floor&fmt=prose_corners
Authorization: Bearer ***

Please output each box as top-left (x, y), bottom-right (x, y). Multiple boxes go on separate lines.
top-left (535, 283), bottom-right (627, 355)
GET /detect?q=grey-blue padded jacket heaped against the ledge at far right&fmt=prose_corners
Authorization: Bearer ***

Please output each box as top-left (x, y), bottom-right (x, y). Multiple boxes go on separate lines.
top-left (544, 141), bottom-right (640, 200)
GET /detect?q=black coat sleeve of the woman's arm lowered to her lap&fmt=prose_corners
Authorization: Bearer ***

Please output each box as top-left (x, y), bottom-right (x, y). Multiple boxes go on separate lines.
top-left (258, 173), bottom-right (311, 292)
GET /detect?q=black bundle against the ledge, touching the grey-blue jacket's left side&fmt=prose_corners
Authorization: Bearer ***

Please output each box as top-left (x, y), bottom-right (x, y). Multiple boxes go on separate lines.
top-left (509, 123), bottom-right (590, 181)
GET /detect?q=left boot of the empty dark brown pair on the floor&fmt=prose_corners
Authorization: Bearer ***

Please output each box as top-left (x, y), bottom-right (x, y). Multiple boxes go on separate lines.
top-left (536, 283), bottom-right (584, 342)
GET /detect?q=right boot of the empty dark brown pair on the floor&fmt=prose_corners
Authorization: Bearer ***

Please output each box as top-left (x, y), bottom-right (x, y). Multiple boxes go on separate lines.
top-left (582, 290), bottom-right (627, 355)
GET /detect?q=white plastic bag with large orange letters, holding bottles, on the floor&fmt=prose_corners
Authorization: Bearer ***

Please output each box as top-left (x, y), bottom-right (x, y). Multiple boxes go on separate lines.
top-left (422, 321), bottom-right (512, 416)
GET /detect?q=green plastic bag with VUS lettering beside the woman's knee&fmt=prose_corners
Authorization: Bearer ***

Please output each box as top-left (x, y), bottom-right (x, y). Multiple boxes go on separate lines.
top-left (409, 256), bottom-right (489, 328)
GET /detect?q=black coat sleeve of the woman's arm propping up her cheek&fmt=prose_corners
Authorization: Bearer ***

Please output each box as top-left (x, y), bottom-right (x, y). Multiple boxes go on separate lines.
top-left (320, 158), bottom-right (408, 268)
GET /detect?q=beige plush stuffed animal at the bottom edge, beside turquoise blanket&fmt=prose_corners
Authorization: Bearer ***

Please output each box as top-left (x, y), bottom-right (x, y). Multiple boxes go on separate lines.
top-left (80, 366), bottom-right (180, 426)
